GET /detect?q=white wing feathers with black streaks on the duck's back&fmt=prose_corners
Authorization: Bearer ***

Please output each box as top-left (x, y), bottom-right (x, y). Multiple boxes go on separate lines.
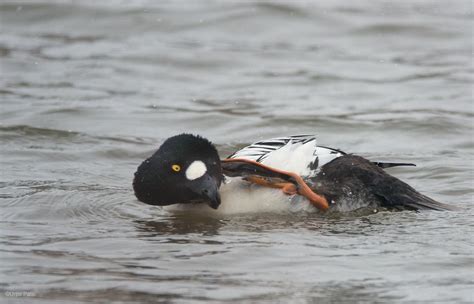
top-left (228, 135), bottom-right (346, 177)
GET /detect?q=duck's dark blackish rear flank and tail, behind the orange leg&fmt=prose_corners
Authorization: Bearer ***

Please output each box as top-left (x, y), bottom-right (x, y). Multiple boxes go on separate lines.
top-left (310, 155), bottom-right (451, 211)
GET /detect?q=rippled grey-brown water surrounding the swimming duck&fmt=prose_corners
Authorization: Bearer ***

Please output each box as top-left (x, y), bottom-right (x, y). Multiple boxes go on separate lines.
top-left (0, 0), bottom-right (474, 303)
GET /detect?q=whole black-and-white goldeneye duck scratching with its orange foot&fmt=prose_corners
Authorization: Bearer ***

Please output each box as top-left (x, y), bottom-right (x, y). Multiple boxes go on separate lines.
top-left (133, 134), bottom-right (453, 213)
